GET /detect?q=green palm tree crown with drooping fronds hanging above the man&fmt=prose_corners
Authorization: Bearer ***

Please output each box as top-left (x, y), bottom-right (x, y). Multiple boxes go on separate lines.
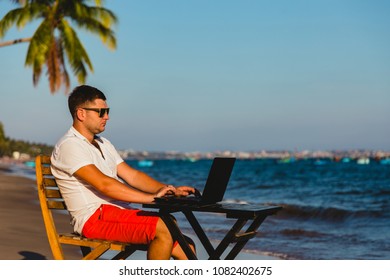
top-left (0, 0), bottom-right (117, 94)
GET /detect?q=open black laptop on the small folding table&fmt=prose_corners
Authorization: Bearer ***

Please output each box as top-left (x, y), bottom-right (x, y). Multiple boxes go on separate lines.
top-left (154, 157), bottom-right (236, 205)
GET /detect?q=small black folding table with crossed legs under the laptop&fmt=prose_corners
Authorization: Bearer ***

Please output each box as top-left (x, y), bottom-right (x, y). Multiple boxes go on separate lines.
top-left (143, 202), bottom-right (282, 260)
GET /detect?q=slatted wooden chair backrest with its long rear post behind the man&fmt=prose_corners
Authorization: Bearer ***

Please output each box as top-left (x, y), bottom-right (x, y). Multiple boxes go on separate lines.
top-left (35, 155), bottom-right (66, 259)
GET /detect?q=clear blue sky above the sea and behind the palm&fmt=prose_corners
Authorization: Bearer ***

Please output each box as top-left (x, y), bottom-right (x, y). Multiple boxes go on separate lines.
top-left (0, 0), bottom-right (390, 151)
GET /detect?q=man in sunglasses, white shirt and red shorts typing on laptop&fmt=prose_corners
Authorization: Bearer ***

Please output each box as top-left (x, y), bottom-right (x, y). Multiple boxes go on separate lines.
top-left (51, 85), bottom-right (195, 259)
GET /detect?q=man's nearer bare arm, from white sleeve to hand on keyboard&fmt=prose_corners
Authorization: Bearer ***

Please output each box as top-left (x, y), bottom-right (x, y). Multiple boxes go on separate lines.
top-left (74, 164), bottom-right (174, 203)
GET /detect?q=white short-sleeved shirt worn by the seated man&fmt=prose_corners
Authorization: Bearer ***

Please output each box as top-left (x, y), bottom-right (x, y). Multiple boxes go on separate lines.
top-left (51, 127), bottom-right (124, 234)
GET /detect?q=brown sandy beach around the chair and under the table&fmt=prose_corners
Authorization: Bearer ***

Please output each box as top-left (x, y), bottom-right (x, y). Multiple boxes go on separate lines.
top-left (0, 166), bottom-right (273, 260)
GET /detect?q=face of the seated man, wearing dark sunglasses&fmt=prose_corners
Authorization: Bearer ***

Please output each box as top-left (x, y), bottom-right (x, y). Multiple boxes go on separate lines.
top-left (82, 99), bottom-right (110, 134)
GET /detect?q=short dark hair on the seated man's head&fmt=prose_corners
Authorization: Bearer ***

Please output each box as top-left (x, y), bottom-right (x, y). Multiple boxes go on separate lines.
top-left (68, 85), bottom-right (106, 118)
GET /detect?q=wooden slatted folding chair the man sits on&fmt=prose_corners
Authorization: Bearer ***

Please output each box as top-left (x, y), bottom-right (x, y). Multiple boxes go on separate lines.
top-left (35, 155), bottom-right (147, 260)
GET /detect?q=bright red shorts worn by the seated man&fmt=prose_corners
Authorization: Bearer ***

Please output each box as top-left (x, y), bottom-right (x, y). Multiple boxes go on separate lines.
top-left (83, 204), bottom-right (159, 244)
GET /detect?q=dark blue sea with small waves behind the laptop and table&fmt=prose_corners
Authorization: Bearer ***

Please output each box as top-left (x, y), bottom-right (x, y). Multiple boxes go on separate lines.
top-left (6, 159), bottom-right (390, 260)
